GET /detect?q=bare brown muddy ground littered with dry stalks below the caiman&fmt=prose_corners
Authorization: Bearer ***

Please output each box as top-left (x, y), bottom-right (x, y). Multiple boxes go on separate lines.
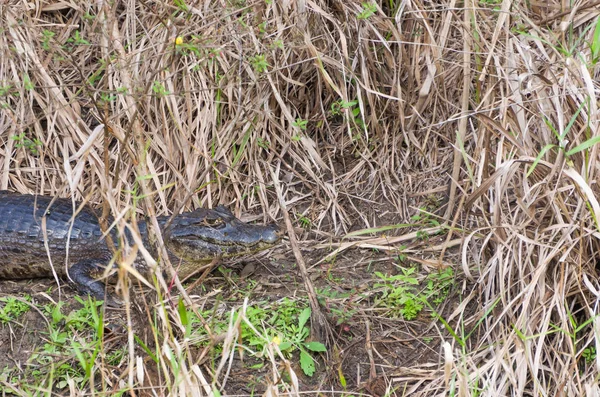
top-left (0, 206), bottom-right (462, 396)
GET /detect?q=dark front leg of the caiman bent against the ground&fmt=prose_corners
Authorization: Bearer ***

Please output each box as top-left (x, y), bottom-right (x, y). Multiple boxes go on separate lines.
top-left (69, 259), bottom-right (122, 307)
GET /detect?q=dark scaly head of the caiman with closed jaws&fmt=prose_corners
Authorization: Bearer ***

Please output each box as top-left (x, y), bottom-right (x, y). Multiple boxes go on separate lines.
top-left (165, 205), bottom-right (282, 263)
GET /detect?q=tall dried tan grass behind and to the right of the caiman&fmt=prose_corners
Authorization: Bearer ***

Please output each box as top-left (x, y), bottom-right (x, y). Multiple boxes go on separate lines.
top-left (0, 0), bottom-right (600, 396)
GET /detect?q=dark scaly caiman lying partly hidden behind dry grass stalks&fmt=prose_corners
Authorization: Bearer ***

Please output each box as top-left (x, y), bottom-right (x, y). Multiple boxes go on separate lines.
top-left (0, 190), bottom-right (281, 305)
